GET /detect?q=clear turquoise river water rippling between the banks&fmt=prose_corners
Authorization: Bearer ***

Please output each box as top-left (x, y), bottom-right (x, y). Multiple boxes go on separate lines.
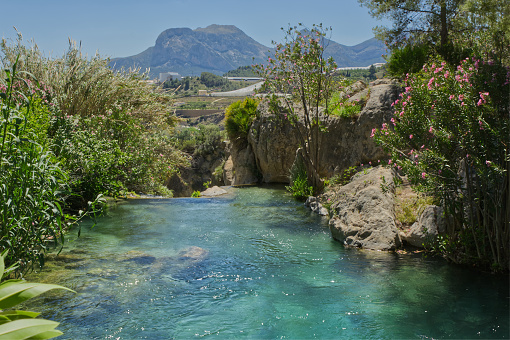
top-left (29, 187), bottom-right (509, 339)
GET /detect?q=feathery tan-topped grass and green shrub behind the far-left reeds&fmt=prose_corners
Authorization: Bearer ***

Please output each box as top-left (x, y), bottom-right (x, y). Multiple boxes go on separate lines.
top-left (2, 34), bottom-right (187, 202)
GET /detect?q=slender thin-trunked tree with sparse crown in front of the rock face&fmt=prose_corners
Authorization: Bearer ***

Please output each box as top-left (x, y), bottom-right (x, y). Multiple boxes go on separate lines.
top-left (254, 24), bottom-right (336, 193)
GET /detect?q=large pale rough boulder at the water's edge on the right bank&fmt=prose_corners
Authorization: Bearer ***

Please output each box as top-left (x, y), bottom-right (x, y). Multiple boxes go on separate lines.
top-left (329, 166), bottom-right (401, 250)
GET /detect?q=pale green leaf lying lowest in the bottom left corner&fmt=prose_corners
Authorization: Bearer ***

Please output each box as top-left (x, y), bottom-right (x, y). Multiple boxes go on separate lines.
top-left (0, 319), bottom-right (63, 340)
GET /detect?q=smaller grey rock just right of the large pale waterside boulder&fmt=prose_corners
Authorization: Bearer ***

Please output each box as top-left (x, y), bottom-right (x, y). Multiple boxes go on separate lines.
top-left (400, 205), bottom-right (446, 248)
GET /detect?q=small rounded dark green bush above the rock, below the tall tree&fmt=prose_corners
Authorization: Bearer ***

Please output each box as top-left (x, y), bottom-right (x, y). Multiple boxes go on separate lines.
top-left (387, 44), bottom-right (429, 78)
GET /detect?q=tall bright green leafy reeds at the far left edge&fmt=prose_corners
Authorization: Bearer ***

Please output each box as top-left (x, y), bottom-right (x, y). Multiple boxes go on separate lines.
top-left (0, 63), bottom-right (102, 275)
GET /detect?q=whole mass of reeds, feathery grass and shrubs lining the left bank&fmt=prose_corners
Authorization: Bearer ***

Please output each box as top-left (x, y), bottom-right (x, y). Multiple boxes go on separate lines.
top-left (0, 35), bottom-right (187, 275)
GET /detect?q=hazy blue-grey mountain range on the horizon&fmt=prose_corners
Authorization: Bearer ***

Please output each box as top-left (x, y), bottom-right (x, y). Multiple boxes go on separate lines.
top-left (110, 25), bottom-right (384, 78)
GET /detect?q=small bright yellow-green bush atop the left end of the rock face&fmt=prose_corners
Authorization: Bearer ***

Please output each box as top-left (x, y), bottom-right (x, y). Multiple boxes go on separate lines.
top-left (225, 97), bottom-right (258, 140)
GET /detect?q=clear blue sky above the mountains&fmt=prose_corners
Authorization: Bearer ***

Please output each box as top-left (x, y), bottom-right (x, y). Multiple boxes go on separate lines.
top-left (0, 0), bottom-right (383, 57)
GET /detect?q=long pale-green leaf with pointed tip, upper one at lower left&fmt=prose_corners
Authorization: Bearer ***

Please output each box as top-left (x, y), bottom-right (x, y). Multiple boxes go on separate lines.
top-left (0, 280), bottom-right (75, 309)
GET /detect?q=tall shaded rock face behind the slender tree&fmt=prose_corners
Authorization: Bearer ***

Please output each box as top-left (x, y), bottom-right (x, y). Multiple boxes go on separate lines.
top-left (225, 82), bottom-right (399, 185)
